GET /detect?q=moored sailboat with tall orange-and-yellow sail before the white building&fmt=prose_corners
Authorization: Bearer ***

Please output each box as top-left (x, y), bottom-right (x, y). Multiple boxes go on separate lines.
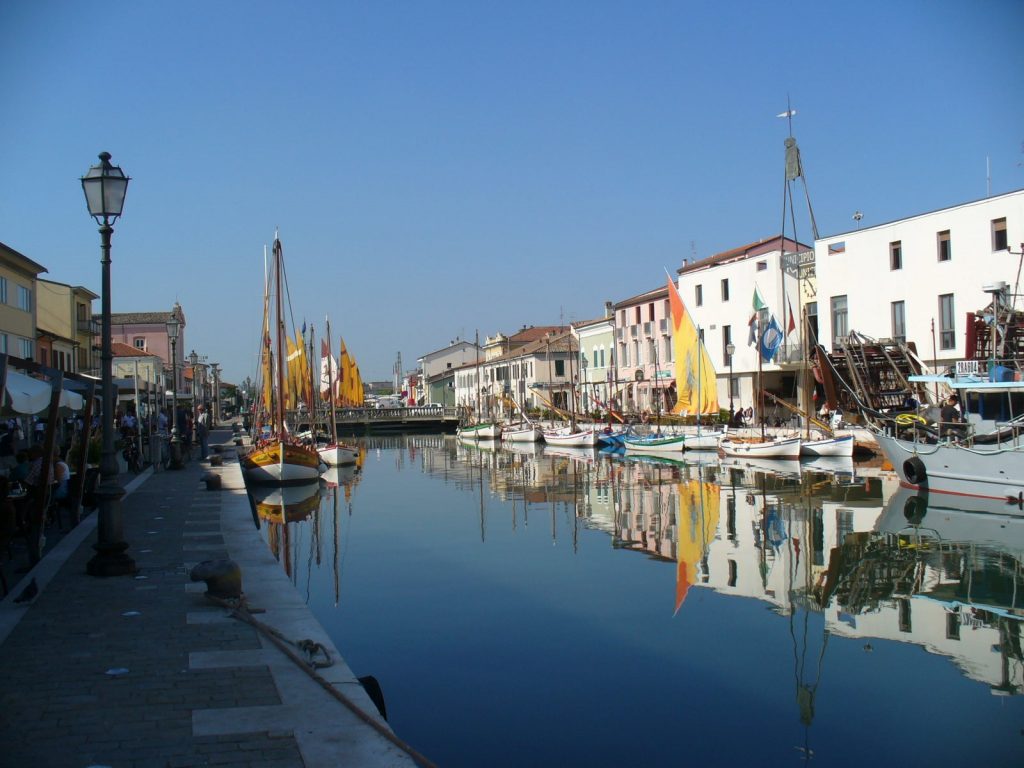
top-left (624, 275), bottom-right (724, 454)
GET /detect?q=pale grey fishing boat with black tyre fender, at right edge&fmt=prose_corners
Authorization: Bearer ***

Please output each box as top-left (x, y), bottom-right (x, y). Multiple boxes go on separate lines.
top-left (877, 374), bottom-right (1024, 510)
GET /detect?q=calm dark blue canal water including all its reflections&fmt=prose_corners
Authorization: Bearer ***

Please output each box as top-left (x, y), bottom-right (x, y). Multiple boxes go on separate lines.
top-left (245, 435), bottom-right (1024, 768)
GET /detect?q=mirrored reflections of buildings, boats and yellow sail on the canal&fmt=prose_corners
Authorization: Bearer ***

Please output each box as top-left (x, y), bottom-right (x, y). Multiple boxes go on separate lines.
top-left (245, 435), bottom-right (1024, 720)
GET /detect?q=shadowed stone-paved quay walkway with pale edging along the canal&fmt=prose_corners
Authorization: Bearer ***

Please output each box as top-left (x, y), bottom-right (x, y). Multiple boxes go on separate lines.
top-left (0, 430), bottom-right (415, 768)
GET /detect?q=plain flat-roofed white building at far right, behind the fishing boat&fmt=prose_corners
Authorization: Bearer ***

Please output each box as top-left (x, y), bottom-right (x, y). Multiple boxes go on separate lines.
top-left (814, 190), bottom-right (1024, 368)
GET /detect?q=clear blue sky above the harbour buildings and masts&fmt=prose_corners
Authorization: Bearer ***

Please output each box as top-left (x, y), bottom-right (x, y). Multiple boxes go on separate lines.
top-left (0, 0), bottom-right (1024, 381)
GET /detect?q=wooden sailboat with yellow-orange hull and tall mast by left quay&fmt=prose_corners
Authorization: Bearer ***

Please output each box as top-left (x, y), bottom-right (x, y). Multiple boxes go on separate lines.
top-left (239, 236), bottom-right (321, 485)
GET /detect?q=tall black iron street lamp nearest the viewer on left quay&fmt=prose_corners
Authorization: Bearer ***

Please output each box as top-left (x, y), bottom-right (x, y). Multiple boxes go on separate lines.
top-left (81, 152), bottom-right (135, 577)
